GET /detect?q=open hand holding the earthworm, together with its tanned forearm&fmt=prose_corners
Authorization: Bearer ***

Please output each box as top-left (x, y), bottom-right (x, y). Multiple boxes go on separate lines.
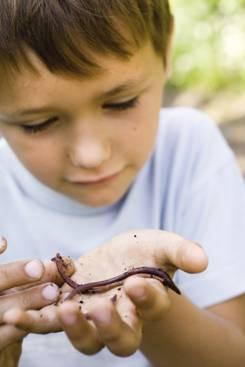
top-left (4, 230), bottom-right (245, 367)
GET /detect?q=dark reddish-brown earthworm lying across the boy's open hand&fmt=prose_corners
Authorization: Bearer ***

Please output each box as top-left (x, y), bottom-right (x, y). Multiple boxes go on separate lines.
top-left (51, 253), bottom-right (181, 300)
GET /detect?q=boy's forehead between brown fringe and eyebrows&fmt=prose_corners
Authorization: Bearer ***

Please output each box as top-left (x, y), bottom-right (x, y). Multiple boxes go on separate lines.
top-left (0, 43), bottom-right (161, 114)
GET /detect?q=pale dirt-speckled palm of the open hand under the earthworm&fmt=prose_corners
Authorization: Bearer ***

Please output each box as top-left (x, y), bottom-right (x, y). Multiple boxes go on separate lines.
top-left (58, 231), bottom-right (175, 315)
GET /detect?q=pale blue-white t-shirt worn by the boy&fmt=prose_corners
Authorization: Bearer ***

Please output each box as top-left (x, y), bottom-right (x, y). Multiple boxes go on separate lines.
top-left (0, 108), bottom-right (245, 367)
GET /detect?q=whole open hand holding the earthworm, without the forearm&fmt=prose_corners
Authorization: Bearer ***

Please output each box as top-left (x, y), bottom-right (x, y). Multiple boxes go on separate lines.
top-left (4, 230), bottom-right (207, 356)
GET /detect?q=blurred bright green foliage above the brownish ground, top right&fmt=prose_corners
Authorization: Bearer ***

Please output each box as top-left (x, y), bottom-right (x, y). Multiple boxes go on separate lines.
top-left (170, 0), bottom-right (245, 92)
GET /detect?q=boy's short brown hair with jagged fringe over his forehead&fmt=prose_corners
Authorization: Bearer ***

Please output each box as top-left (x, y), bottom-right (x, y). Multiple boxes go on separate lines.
top-left (0, 0), bottom-right (173, 76)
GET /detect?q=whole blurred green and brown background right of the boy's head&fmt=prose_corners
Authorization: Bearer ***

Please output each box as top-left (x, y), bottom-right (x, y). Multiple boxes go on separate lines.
top-left (165, 0), bottom-right (245, 173)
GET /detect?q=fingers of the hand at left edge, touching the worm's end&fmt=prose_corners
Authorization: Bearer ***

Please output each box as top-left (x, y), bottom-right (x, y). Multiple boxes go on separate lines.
top-left (0, 238), bottom-right (73, 356)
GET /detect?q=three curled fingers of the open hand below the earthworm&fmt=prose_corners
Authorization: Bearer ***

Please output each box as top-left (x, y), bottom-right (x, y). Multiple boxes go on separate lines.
top-left (59, 276), bottom-right (170, 356)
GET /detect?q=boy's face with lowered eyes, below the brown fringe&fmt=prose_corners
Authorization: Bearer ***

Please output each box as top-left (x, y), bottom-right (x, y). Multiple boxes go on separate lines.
top-left (0, 44), bottom-right (165, 207)
